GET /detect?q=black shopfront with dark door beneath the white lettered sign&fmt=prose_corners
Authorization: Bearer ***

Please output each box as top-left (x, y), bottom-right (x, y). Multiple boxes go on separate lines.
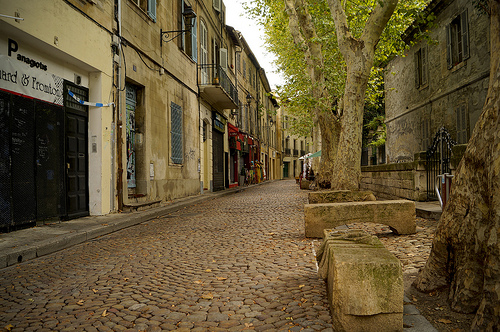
top-left (0, 81), bottom-right (89, 232)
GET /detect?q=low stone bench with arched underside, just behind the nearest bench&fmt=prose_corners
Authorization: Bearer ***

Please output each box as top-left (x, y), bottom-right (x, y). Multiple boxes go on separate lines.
top-left (304, 200), bottom-right (417, 237)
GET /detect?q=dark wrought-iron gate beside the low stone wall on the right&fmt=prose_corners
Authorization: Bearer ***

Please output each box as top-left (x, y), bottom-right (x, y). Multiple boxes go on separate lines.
top-left (426, 127), bottom-right (457, 201)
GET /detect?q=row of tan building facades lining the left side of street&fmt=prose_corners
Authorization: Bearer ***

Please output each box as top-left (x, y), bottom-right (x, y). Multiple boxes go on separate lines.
top-left (0, 0), bottom-right (277, 231)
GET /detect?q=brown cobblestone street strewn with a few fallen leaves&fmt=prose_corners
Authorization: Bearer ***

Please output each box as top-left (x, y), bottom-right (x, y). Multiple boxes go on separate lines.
top-left (0, 181), bottom-right (332, 331)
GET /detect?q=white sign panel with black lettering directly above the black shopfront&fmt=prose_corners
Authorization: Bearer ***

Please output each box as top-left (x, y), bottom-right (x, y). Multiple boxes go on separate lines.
top-left (0, 55), bottom-right (63, 106)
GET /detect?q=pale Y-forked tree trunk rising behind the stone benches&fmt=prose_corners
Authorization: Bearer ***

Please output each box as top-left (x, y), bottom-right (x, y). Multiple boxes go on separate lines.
top-left (328, 0), bottom-right (398, 190)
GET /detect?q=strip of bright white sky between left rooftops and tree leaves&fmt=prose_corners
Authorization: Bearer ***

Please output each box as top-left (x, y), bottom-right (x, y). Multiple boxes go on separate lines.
top-left (224, 0), bottom-right (283, 89)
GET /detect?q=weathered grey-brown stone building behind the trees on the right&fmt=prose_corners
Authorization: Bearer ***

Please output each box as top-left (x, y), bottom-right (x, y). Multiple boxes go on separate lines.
top-left (385, 0), bottom-right (490, 163)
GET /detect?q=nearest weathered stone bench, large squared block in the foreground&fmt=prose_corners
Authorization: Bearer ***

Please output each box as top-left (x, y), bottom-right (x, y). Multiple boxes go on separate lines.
top-left (316, 230), bottom-right (404, 332)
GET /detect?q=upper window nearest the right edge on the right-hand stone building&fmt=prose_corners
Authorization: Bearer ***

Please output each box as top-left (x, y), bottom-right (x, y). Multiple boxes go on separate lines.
top-left (446, 10), bottom-right (469, 69)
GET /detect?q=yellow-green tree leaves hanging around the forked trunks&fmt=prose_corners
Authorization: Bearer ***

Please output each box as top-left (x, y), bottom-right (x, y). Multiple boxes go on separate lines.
top-left (245, 0), bottom-right (429, 137)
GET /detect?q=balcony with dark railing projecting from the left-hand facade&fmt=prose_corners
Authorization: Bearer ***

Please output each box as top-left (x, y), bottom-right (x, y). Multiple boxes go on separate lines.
top-left (198, 64), bottom-right (238, 109)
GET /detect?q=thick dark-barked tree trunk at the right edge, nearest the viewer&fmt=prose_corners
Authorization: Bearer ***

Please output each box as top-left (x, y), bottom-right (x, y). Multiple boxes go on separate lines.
top-left (414, 0), bottom-right (500, 331)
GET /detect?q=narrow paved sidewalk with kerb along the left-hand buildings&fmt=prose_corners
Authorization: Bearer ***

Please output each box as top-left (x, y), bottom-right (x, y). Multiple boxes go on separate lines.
top-left (0, 184), bottom-right (250, 269)
